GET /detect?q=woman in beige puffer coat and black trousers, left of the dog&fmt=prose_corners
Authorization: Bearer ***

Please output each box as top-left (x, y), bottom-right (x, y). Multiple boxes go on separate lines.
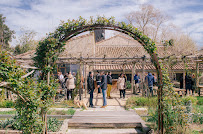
top-left (66, 72), bottom-right (75, 100)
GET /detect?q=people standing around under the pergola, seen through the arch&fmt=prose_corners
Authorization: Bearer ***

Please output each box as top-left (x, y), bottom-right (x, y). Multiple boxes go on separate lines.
top-left (58, 71), bottom-right (158, 108)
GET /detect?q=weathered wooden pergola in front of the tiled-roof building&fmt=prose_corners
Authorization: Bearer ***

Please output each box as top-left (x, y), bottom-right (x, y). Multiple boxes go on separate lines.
top-left (16, 51), bottom-right (203, 98)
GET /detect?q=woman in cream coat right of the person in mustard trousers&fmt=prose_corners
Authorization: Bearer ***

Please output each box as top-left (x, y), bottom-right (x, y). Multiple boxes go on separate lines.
top-left (117, 73), bottom-right (125, 99)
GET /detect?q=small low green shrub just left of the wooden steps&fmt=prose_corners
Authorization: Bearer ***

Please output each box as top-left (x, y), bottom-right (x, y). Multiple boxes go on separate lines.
top-left (47, 118), bottom-right (63, 132)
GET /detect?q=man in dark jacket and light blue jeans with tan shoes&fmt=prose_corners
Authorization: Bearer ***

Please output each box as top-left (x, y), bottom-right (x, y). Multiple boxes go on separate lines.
top-left (100, 71), bottom-right (107, 108)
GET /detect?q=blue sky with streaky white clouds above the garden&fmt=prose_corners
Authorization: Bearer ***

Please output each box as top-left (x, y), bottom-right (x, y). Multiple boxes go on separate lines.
top-left (0, 0), bottom-right (203, 48)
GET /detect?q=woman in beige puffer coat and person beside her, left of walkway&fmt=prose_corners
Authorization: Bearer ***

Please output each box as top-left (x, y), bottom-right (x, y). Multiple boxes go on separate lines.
top-left (58, 72), bottom-right (76, 100)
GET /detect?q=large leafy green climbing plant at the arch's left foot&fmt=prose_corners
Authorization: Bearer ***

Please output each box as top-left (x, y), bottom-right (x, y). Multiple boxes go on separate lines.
top-left (0, 51), bottom-right (57, 134)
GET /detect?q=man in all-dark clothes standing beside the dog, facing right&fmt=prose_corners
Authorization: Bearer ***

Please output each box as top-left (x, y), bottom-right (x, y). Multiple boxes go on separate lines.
top-left (87, 72), bottom-right (95, 108)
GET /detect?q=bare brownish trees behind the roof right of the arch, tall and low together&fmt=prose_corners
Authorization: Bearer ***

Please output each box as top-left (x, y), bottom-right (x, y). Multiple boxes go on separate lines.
top-left (126, 5), bottom-right (197, 55)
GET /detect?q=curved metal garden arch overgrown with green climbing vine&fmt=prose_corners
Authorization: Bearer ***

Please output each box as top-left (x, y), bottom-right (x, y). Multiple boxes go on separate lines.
top-left (34, 16), bottom-right (163, 133)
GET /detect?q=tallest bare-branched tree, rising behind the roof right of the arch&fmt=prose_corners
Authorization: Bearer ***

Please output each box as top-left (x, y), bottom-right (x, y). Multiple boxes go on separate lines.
top-left (126, 5), bottom-right (169, 41)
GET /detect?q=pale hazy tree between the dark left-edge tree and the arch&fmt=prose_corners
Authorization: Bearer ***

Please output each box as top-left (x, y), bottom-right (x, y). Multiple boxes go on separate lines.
top-left (14, 29), bottom-right (38, 54)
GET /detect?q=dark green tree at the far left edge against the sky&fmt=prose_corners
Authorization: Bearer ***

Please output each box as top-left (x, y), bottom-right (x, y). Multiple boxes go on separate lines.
top-left (0, 14), bottom-right (15, 49)
